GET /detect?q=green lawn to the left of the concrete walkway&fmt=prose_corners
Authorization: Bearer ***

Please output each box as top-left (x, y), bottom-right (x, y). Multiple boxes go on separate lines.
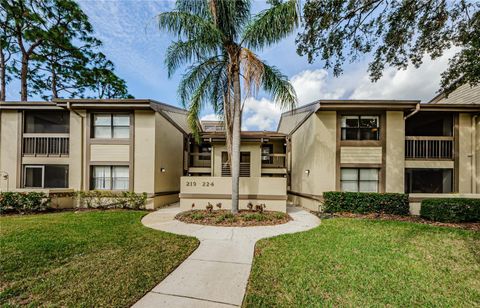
top-left (0, 211), bottom-right (198, 307)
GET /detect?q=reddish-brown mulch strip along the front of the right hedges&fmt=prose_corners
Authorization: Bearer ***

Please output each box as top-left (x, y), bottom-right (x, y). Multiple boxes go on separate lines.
top-left (314, 212), bottom-right (480, 231)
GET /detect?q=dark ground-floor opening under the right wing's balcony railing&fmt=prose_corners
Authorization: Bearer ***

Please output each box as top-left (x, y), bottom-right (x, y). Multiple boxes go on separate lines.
top-left (405, 169), bottom-right (453, 193)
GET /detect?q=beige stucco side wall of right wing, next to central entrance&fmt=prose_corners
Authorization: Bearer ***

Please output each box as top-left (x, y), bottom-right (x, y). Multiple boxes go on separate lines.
top-left (290, 111), bottom-right (337, 206)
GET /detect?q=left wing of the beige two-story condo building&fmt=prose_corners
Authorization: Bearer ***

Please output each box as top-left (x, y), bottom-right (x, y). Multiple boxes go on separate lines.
top-left (0, 99), bottom-right (189, 207)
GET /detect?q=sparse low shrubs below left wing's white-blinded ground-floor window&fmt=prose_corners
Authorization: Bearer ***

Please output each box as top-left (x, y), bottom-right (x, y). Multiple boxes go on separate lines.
top-left (77, 190), bottom-right (147, 210)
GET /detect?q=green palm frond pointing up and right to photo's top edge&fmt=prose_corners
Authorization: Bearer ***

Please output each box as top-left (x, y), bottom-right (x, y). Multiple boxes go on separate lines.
top-left (243, 0), bottom-right (300, 49)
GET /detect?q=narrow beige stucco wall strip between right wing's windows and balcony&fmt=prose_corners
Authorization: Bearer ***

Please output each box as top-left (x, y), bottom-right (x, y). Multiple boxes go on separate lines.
top-left (385, 111), bottom-right (405, 193)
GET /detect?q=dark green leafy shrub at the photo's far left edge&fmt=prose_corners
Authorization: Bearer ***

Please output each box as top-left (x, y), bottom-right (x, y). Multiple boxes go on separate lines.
top-left (0, 192), bottom-right (51, 214)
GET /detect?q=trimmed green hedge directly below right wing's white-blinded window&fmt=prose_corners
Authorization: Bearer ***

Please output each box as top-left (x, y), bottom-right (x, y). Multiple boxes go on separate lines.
top-left (323, 191), bottom-right (410, 215)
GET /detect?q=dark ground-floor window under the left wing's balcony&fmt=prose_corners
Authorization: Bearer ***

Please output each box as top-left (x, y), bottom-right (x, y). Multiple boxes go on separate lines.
top-left (23, 165), bottom-right (68, 188)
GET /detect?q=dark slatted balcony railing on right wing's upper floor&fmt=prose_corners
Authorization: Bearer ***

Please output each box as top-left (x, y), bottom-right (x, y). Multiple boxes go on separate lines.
top-left (405, 136), bottom-right (454, 160)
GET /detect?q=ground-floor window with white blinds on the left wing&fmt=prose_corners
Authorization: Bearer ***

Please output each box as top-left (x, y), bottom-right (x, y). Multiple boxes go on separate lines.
top-left (90, 166), bottom-right (129, 190)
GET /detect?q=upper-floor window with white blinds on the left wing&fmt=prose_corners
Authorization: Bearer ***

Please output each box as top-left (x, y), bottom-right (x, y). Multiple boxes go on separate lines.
top-left (92, 113), bottom-right (130, 139)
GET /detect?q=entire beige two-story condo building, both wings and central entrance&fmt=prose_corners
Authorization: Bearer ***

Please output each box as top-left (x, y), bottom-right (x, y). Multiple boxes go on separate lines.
top-left (0, 85), bottom-right (480, 214)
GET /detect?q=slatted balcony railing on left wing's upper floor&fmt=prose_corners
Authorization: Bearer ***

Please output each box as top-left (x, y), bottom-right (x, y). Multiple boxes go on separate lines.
top-left (23, 134), bottom-right (70, 156)
